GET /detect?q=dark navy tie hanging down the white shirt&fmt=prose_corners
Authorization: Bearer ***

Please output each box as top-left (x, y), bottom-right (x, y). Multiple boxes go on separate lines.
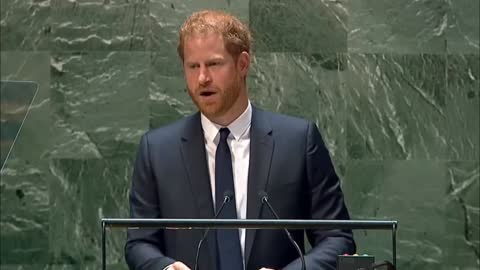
top-left (215, 128), bottom-right (243, 270)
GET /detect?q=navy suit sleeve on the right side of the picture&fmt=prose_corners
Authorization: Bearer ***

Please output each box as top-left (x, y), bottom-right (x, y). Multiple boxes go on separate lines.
top-left (284, 123), bottom-right (355, 270)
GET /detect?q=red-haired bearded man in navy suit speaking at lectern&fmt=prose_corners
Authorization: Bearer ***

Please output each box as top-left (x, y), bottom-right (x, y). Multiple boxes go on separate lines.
top-left (125, 11), bottom-right (355, 270)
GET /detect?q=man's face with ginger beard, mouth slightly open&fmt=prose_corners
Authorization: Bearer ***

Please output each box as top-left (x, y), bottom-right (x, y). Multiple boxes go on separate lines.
top-left (183, 33), bottom-right (248, 123)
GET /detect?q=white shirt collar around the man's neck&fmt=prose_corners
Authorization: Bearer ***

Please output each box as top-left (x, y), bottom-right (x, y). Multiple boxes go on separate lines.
top-left (201, 101), bottom-right (252, 142)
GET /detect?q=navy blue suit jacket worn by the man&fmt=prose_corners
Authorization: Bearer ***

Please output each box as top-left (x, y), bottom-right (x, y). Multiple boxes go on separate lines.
top-left (125, 107), bottom-right (355, 270)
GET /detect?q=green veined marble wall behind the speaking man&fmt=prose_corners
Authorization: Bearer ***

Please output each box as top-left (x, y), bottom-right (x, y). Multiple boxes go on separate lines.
top-left (0, 0), bottom-right (480, 270)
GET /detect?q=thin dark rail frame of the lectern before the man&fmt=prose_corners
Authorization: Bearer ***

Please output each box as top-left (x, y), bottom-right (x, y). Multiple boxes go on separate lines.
top-left (101, 218), bottom-right (398, 270)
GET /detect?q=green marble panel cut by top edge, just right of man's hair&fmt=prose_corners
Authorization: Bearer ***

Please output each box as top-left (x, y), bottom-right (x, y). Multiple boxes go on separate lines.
top-left (250, 0), bottom-right (348, 54)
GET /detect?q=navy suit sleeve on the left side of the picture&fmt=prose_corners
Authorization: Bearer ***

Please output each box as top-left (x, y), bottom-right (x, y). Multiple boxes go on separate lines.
top-left (125, 133), bottom-right (175, 270)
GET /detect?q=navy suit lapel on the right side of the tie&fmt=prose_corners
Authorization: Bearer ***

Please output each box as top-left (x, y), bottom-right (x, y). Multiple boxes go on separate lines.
top-left (245, 107), bottom-right (274, 265)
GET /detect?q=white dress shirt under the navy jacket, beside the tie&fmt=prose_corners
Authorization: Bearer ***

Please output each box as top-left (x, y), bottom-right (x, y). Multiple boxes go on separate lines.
top-left (201, 101), bottom-right (252, 262)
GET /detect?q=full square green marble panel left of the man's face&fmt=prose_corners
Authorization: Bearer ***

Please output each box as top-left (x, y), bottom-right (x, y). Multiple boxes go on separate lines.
top-left (51, 52), bottom-right (150, 158)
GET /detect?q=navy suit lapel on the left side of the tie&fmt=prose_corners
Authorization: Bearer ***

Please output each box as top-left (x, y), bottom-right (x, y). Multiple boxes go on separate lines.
top-left (181, 113), bottom-right (216, 269)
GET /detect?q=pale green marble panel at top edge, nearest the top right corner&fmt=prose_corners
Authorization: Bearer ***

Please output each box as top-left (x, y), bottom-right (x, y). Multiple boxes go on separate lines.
top-left (346, 0), bottom-right (451, 54)
